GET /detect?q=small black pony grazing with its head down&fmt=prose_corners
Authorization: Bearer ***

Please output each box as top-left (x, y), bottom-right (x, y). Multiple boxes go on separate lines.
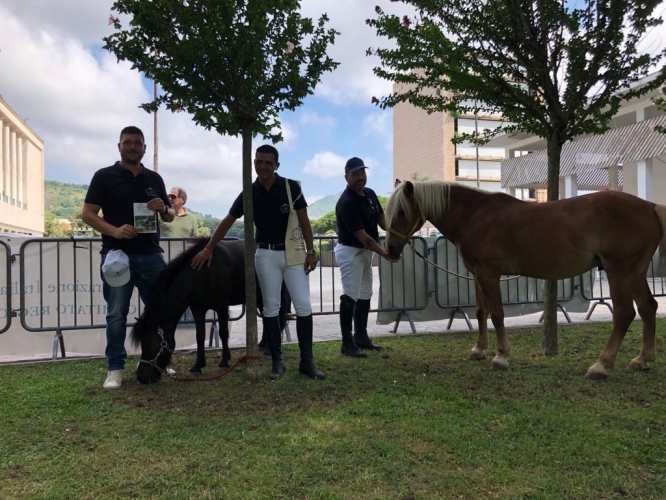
top-left (132, 238), bottom-right (286, 384)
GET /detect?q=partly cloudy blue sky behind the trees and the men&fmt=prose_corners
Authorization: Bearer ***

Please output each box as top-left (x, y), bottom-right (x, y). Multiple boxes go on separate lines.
top-left (0, 0), bottom-right (405, 217)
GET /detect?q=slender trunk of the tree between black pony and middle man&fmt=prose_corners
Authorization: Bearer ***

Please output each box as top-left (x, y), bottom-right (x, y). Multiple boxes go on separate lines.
top-left (243, 129), bottom-right (259, 380)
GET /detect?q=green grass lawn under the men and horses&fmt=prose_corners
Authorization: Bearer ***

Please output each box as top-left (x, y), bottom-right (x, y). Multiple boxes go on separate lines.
top-left (0, 320), bottom-right (666, 500)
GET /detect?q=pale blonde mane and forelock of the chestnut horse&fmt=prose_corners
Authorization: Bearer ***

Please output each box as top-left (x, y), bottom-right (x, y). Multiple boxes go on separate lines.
top-left (385, 181), bottom-right (451, 222)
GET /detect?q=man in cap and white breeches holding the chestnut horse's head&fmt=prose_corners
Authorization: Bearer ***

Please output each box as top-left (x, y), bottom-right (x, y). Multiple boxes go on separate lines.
top-left (335, 157), bottom-right (395, 358)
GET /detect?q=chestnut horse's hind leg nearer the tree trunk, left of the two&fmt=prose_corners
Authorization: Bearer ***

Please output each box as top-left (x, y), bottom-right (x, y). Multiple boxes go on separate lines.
top-left (585, 274), bottom-right (636, 380)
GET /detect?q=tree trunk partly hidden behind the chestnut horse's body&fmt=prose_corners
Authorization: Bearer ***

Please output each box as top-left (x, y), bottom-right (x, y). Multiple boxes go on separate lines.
top-left (543, 132), bottom-right (562, 356)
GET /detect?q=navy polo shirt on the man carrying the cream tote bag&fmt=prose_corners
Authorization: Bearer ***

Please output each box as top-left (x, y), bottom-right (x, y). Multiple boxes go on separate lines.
top-left (229, 174), bottom-right (308, 245)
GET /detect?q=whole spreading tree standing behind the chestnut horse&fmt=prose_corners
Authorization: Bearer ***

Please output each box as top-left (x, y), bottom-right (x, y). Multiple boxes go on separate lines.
top-left (367, 0), bottom-right (666, 355)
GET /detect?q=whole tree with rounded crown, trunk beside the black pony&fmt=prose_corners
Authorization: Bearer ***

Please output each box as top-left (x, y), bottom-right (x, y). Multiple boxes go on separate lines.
top-left (104, 0), bottom-right (337, 378)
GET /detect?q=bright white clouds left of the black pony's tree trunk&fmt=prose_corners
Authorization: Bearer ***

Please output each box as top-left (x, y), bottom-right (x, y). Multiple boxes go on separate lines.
top-left (0, 0), bottom-right (246, 213)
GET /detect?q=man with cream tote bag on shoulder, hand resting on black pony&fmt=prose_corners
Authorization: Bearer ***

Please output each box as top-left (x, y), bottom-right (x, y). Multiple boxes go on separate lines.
top-left (192, 144), bottom-right (325, 380)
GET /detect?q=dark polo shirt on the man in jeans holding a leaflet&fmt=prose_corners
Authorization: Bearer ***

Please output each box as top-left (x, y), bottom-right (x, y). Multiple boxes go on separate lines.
top-left (85, 162), bottom-right (171, 254)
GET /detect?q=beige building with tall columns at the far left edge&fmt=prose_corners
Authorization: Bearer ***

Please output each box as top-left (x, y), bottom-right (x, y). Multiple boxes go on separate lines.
top-left (0, 97), bottom-right (44, 236)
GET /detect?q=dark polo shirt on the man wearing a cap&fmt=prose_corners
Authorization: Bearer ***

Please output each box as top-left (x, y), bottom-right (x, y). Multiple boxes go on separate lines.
top-left (335, 186), bottom-right (384, 248)
